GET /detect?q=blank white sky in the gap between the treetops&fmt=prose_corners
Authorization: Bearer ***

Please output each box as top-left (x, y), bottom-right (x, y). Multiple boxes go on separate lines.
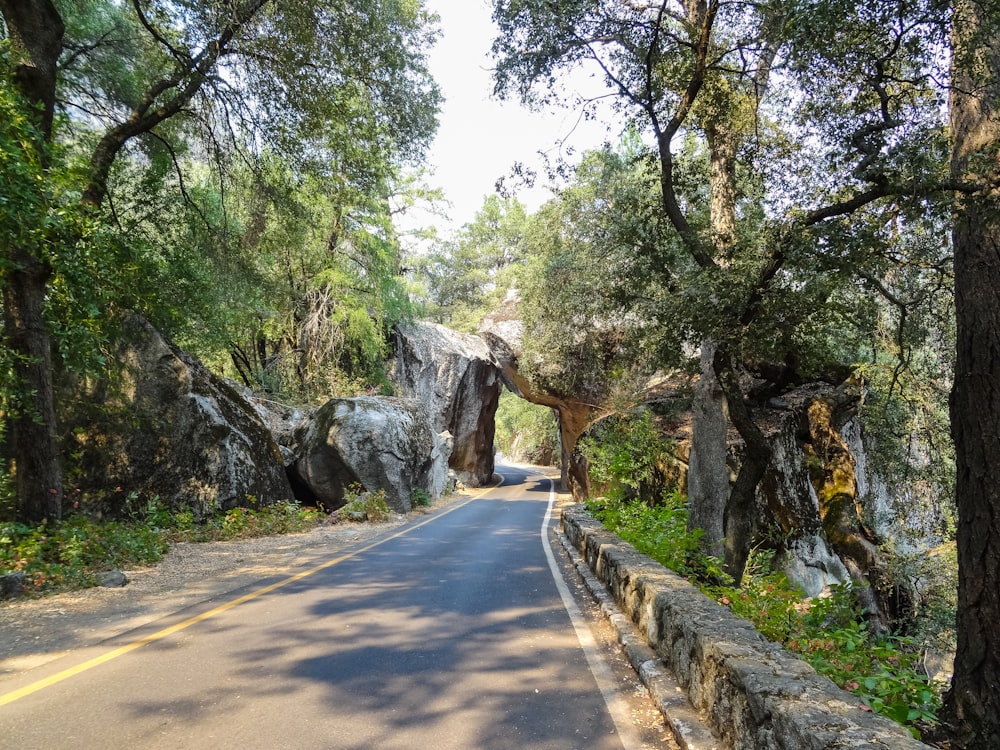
top-left (411, 0), bottom-right (617, 234)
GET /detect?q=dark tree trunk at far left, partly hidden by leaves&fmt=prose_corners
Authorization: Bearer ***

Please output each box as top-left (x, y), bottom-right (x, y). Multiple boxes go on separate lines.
top-left (0, 0), bottom-right (64, 521)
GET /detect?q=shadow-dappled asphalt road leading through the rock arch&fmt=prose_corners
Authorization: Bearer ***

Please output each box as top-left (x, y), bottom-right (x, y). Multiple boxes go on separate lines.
top-left (0, 467), bottom-right (668, 750)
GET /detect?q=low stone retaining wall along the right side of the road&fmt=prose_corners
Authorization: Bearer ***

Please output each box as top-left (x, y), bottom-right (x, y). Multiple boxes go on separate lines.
top-left (562, 505), bottom-right (929, 750)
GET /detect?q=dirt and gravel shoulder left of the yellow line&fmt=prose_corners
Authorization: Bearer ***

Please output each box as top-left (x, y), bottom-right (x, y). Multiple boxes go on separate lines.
top-left (0, 493), bottom-right (468, 683)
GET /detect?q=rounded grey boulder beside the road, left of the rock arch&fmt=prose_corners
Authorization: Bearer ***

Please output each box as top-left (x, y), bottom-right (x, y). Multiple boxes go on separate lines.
top-left (291, 396), bottom-right (448, 513)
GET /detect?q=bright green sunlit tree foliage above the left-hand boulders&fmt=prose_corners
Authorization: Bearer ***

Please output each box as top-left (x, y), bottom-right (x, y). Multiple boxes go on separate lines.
top-left (189, 158), bottom-right (412, 402)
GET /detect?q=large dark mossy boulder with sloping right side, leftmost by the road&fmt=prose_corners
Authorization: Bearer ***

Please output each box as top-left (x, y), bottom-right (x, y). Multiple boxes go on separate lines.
top-left (63, 315), bottom-right (292, 516)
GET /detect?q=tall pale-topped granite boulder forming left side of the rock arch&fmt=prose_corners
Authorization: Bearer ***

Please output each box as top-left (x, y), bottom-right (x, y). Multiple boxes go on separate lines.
top-left (390, 323), bottom-right (503, 487)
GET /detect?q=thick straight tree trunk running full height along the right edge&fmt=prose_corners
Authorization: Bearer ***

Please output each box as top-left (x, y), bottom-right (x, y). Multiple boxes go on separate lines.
top-left (943, 0), bottom-right (1000, 750)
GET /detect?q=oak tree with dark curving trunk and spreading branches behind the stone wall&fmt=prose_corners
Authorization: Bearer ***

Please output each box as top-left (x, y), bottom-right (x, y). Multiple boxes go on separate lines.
top-left (493, 0), bottom-right (943, 579)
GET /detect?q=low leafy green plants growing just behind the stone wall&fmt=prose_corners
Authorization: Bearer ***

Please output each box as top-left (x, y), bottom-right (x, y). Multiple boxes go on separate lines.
top-left (583, 412), bottom-right (954, 737)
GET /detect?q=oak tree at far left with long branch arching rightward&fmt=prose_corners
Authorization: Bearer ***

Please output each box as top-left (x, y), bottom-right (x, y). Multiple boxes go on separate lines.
top-left (0, 0), bottom-right (439, 520)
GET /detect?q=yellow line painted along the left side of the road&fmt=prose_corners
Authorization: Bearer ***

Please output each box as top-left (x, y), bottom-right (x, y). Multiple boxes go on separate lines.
top-left (0, 485), bottom-right (499, 706)
